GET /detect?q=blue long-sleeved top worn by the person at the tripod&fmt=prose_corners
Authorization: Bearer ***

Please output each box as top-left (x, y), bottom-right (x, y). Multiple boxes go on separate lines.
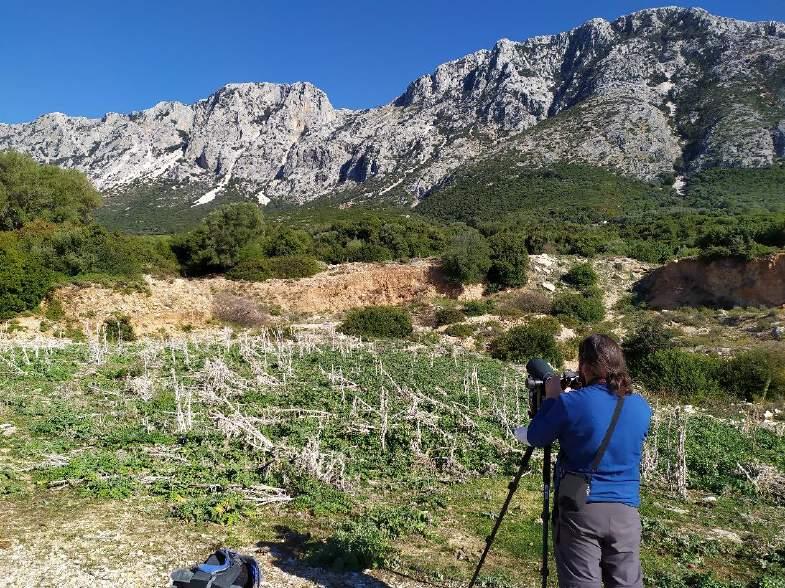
top-left (527, 384), bottom-right (652, 508)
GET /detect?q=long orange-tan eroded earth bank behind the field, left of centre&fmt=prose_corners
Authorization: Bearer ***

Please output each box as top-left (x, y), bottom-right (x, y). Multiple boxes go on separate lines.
top-left (55, 261), bottom-right (461, 334)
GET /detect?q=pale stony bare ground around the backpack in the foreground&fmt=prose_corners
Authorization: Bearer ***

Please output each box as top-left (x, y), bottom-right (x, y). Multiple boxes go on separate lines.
top-left (0, 495), bottom-right (423, 588)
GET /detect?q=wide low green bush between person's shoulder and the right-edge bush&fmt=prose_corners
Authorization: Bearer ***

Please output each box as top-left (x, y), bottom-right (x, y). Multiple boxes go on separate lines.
top-left (639, 349), bottom-right (723, 399)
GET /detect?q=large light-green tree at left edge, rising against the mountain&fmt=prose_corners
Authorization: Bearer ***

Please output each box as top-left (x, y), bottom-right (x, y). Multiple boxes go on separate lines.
top-left (0, 151), bottom-right (101, 230)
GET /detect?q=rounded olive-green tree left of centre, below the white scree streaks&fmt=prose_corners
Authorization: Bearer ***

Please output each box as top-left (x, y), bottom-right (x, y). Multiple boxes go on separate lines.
top-left (172, 202), bottom-right (264, 275)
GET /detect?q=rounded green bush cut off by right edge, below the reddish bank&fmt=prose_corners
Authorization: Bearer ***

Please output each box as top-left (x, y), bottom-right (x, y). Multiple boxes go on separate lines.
top-left (721, 348), bottom-right (785, 402)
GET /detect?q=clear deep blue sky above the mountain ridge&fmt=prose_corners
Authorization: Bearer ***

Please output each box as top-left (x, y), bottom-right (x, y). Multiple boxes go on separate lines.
top-left (0, 0), bottom-right (785, 122)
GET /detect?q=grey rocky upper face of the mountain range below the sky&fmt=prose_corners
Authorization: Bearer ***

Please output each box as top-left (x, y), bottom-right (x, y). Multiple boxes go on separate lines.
top-left (0, 8), bottom-right (785, 211)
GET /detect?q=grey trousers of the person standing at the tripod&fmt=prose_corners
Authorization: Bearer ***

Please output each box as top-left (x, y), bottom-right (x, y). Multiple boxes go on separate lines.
top-left (553, 503), bottom-right (643, 588)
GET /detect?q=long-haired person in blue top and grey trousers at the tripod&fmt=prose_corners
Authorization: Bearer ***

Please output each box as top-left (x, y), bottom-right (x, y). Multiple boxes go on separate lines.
top-left (516, 335), bottom-right (652, 588)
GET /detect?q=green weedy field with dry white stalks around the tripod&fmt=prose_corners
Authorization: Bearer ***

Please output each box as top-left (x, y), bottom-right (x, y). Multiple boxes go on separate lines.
top-left (0, 332), bottom-right (785, 586)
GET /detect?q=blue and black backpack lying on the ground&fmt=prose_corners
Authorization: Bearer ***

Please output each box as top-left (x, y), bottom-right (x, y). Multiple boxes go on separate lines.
top-left (171, 549), bottom-right (262, 588)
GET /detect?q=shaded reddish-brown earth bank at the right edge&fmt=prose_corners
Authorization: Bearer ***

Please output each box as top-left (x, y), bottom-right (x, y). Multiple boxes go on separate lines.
top-left (638, 254), bottom-right (785, 309)
